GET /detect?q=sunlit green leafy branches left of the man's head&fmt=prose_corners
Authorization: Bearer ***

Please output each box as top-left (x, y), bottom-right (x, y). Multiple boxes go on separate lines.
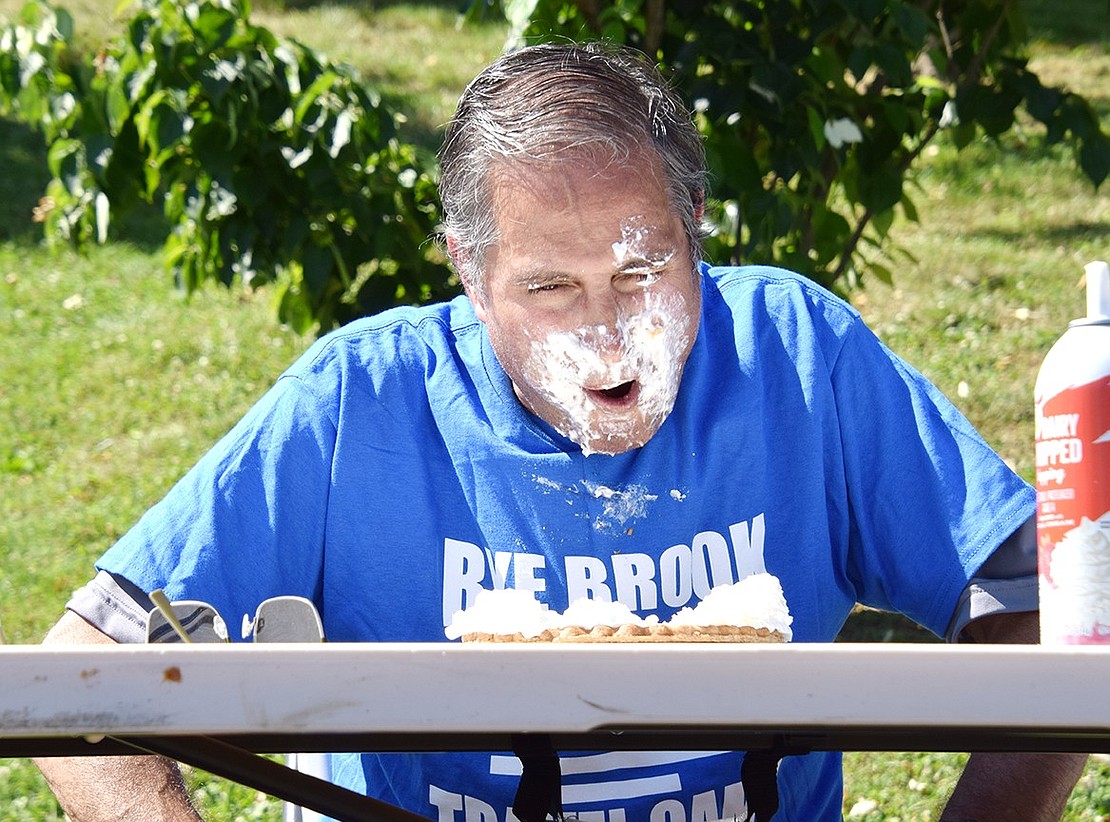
top-left (0, 0), bottom-right (457, 332)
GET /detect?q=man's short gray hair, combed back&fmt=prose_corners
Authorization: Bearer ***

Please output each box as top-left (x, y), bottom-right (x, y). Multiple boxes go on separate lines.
top-left (440, 43), bottom-right (705, 287)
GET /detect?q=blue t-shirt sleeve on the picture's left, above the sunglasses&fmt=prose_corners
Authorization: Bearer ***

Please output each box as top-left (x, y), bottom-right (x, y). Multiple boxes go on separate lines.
top-left (92, 376), bottom-right (336, 636)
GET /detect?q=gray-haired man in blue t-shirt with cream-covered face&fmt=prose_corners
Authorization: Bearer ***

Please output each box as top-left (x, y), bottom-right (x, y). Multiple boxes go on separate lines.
top-left (36, 47), bottom-right (1083, 822)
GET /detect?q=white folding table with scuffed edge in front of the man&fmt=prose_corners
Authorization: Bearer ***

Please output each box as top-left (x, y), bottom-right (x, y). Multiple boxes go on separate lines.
top-left (0, 643), bottom-right (1110, 819)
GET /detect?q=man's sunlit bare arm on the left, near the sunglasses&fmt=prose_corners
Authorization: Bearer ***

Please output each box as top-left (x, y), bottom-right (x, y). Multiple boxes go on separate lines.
top-left (34, 611), bottom-right (201, 822)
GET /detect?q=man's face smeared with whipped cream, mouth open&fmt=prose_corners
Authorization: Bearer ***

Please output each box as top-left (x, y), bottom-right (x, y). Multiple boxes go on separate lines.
top-left (470, 156), bottom-right (700, 454)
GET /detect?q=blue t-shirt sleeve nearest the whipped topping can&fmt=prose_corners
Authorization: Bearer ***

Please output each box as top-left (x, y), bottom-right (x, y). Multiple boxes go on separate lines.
top-left (833, 322), bottom-right (1036, 637)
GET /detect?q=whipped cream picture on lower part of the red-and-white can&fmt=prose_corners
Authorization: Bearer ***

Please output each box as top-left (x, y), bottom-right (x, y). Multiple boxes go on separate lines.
top-left (1046, 511), bottom-right (1110, 636)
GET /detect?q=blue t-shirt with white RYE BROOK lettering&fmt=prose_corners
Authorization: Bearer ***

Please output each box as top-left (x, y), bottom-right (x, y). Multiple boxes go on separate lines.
top-left (99, 266), bottom-right (1033, 822)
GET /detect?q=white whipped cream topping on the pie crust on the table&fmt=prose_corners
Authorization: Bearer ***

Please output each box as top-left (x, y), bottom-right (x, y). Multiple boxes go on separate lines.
top-left (444, 574), bottom-right (794, 642)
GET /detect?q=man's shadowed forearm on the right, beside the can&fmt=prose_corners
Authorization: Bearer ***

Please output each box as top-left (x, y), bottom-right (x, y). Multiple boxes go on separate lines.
top-left (940, 611), bottom-right (1087, 822)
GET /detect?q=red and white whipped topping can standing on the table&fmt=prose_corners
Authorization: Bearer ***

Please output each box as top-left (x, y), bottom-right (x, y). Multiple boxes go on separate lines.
top-left (1033, 261), bottom-right (1110, 646)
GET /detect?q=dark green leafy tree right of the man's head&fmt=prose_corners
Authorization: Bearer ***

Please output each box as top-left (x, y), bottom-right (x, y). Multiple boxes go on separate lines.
top-left (470, 0), bottom-right (1110, 287)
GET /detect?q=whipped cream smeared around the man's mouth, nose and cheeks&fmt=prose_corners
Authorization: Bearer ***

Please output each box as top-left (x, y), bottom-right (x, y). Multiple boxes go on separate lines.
top-left (524, 291), bottom-right (690, 455)
